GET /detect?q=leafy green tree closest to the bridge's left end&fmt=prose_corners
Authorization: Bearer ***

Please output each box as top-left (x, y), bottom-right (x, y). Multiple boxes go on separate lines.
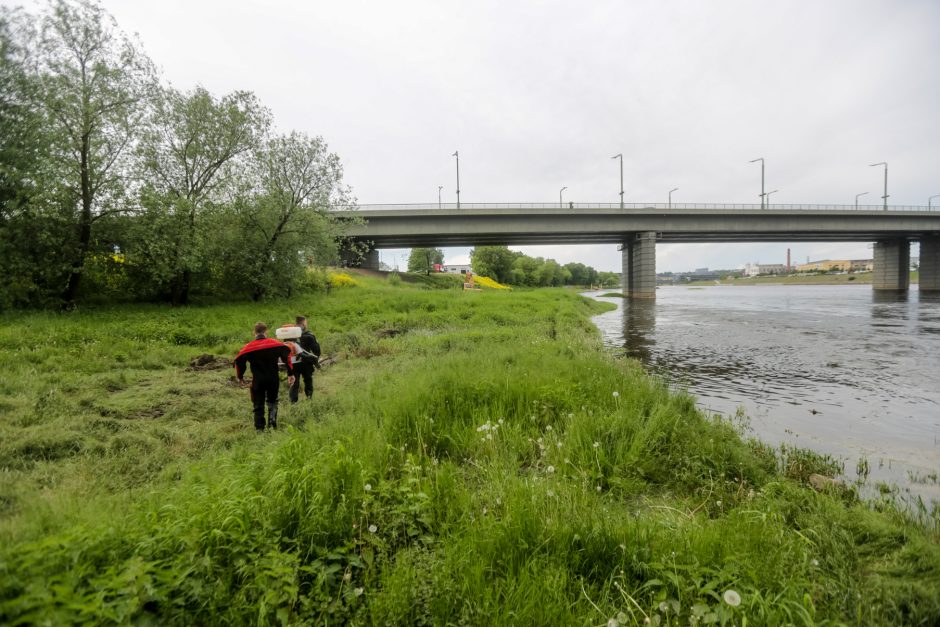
top-left (218, 132), bottom-right (355, 300)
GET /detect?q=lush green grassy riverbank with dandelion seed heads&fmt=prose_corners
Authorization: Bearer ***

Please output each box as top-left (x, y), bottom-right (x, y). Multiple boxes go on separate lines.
top-left (0, 277), bottom-right (940, 625)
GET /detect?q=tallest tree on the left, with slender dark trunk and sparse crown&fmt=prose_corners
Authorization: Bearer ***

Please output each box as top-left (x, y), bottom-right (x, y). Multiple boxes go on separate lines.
top-left (38, 0), bottom-right (156, 306)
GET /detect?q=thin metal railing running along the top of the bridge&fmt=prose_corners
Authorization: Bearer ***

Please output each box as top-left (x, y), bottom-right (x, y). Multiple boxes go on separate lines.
top-left (342, 202), bottom-right (940, 212)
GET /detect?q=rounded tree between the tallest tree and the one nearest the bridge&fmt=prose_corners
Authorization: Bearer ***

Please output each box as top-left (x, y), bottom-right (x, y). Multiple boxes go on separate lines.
top-left (132, 87), bottom-right (270, 304)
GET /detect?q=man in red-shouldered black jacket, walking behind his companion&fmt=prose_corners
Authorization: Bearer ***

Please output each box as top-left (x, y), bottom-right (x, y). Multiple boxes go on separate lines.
top-left (235, 322), bottom-right (294, 431)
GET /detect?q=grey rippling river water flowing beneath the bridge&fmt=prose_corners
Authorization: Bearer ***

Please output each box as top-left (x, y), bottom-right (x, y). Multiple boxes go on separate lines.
top-left (587, 285), bottom-right (940, 502)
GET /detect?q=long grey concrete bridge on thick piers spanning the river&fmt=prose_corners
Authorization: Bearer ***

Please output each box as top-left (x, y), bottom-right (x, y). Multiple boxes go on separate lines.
top-left (334, 203), bottom-right (940, 298)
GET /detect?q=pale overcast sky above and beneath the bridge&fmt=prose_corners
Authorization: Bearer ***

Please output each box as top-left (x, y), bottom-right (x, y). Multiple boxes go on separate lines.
top-left (9, 0), bottom-right (940, 271)
